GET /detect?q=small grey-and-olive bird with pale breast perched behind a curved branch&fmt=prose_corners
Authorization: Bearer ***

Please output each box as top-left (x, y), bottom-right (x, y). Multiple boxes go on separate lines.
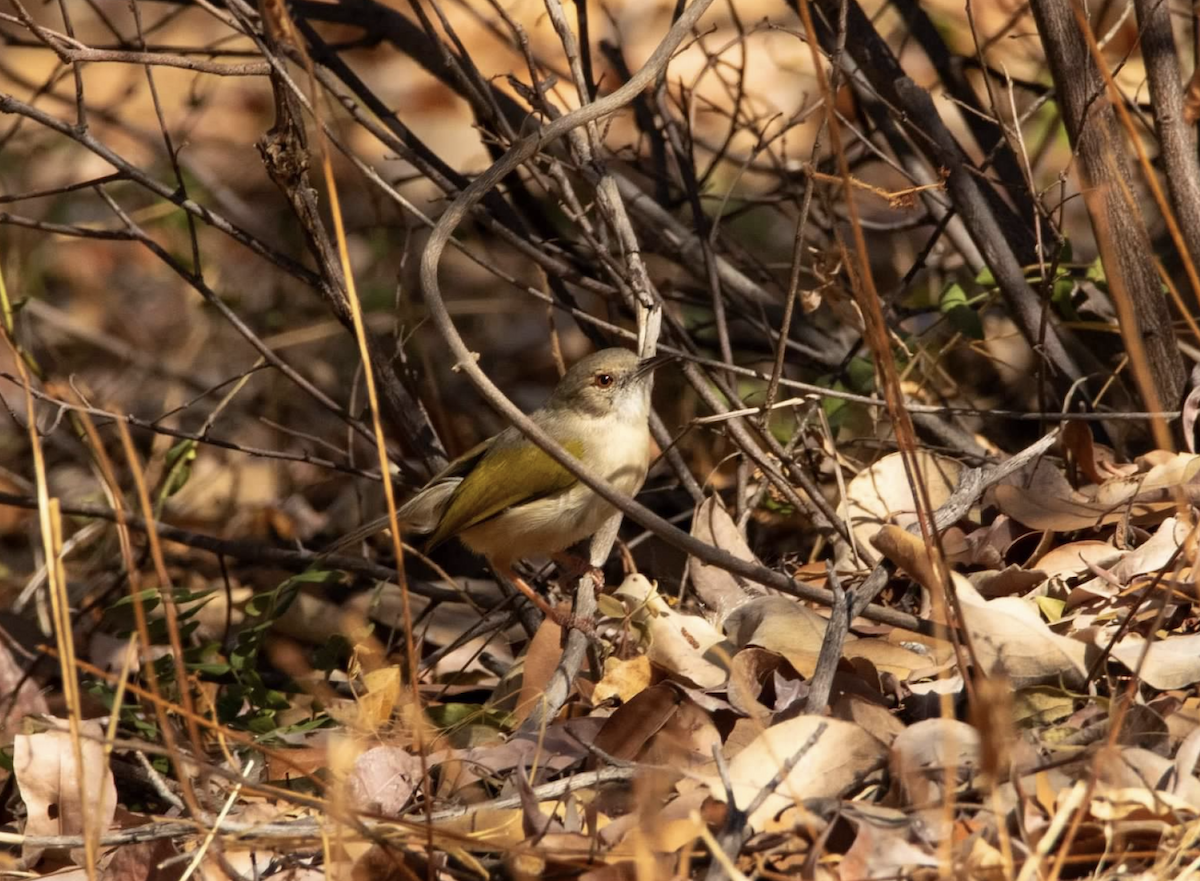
top-left (333, 348), bottom-right (661, 617)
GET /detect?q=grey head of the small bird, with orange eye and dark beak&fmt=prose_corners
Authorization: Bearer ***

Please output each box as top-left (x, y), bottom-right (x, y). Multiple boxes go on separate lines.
top-left (546, 348), bottom-right (658, 421)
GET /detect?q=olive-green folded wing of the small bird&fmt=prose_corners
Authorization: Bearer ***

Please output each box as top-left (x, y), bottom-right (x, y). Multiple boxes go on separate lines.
top-left (428, 441), bottom-right (583, 547)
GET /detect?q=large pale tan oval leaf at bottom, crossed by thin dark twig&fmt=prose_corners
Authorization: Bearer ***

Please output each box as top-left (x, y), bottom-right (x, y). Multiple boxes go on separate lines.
top-left (707, 715), bottom-right (886, 829)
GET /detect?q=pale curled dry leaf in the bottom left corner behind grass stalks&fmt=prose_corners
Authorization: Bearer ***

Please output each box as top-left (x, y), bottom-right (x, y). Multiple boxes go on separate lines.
top-left (12, 719), bottom-right (116, 865)
